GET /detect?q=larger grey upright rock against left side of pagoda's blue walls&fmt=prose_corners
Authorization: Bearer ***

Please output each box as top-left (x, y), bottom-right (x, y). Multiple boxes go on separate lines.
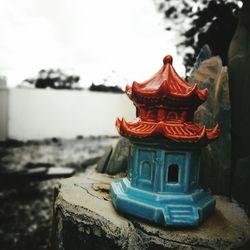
top-left (102, 137), bottom-right (129, 175)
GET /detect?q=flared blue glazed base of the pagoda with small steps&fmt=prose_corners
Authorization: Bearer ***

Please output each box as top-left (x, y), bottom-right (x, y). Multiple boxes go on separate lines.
top-left (110, 178), bottom-right (216, 226)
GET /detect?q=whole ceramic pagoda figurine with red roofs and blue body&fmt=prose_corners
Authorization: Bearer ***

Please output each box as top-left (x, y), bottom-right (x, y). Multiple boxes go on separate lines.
top-left (110, 55), bottom-right (219, 226)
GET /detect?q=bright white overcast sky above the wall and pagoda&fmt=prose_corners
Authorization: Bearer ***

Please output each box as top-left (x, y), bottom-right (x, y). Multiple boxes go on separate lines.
top-left (0, 0), bottom-right (184, 87)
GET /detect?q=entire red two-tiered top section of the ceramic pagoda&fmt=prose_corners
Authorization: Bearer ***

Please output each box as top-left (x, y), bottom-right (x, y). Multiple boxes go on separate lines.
top-left (116, 56), bottom-right (219, 144)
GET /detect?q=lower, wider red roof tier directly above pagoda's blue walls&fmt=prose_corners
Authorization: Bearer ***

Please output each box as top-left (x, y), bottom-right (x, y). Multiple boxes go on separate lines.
top-left (116, 119), bottom-right (220, 143)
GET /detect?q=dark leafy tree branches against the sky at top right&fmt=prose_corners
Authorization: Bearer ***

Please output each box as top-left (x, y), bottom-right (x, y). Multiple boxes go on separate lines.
top-left (155, 0), bottom-right (242, 71)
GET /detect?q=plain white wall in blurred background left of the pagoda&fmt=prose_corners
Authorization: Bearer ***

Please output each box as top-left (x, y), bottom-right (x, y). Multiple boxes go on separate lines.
top-left (8, 89), bottom-right (135, 140)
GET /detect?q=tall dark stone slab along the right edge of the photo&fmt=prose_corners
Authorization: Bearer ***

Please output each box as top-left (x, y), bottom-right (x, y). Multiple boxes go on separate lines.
top-left (228, 0), bottom-right (250, 214)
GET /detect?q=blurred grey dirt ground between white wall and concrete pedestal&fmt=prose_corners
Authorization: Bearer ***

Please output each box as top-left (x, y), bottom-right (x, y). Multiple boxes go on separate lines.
top-left (0, 137), bottom-right (117, 250)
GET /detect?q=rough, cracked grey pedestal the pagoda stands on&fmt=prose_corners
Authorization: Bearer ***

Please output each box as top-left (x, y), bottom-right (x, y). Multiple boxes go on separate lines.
top-left (53, 168), bottom-right (250, 250)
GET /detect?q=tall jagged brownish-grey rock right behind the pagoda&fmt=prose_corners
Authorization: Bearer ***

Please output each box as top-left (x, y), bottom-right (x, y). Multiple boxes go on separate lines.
top-left (189, 56), bottom-right (231, 195)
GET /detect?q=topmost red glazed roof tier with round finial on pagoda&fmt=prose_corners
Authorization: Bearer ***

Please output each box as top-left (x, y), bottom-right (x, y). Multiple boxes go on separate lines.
top-left (126, 55), bottom-right (208, 105)
